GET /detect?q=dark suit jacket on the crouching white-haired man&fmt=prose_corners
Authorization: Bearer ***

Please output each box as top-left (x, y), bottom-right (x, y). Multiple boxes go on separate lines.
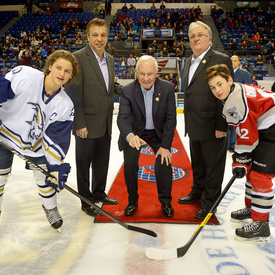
top-left (117, 78), bottom-right (176, 151)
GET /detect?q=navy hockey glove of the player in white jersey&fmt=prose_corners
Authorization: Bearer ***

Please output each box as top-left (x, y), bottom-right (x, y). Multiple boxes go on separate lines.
top-left (45, 163), bottom-right (71, 192)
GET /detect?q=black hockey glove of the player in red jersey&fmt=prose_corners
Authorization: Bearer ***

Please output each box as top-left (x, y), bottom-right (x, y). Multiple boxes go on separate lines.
top-left (232, 153), bottom-right (252, 179)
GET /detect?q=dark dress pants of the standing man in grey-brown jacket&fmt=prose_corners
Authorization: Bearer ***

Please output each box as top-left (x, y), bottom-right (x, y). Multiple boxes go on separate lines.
top-left (75, 133), bottom-right (111, 207)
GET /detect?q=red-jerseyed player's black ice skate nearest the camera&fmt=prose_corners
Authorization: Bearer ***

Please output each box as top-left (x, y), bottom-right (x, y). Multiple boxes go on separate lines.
top-left (235, 221), bottom-right (270, 243)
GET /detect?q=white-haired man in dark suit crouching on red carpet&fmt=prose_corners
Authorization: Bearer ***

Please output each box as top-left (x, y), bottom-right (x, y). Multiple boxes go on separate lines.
top-left (117, 55), bottom-right (176, 217)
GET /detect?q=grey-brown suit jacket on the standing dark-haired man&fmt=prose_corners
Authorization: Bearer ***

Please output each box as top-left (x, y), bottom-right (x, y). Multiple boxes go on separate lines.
top-left (65, 45), bottom-right (120, 138)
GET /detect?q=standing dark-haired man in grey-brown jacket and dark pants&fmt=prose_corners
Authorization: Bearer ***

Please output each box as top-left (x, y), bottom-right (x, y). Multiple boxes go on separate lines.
top-left (65, 18), bottom-right (120, 217)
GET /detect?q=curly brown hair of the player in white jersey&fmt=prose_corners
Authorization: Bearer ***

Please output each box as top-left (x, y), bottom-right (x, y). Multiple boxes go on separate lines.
top-left (43, 50), bottom-right (79, 79)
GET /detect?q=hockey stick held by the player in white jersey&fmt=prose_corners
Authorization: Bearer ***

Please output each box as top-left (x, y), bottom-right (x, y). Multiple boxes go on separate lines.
top-left (0, 140), bottom-right (157, 237)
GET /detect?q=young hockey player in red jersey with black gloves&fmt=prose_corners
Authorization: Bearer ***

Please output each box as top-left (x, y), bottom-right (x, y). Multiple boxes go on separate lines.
top-left (205, 65), bottom-right (275, 242)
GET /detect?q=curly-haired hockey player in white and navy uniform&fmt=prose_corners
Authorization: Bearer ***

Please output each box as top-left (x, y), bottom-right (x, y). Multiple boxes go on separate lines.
top-left (0, 50), bottom-right (78, 229)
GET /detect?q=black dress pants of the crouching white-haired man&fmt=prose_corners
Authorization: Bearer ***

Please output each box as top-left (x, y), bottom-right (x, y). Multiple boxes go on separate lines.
top-left (124, 130), bottom-right (172, 204)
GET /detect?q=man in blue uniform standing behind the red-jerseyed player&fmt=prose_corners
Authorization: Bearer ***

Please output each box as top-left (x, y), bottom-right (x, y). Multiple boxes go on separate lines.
top-left (227, 55), bottom-right (252, 152)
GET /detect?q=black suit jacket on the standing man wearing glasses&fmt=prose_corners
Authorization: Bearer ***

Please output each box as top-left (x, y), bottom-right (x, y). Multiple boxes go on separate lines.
top-left (183, 49), bottom-right (234, 140)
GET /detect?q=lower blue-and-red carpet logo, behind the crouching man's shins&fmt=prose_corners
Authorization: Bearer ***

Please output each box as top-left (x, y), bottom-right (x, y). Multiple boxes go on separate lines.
top-left (138, 165), bottom-right (189, 182)
